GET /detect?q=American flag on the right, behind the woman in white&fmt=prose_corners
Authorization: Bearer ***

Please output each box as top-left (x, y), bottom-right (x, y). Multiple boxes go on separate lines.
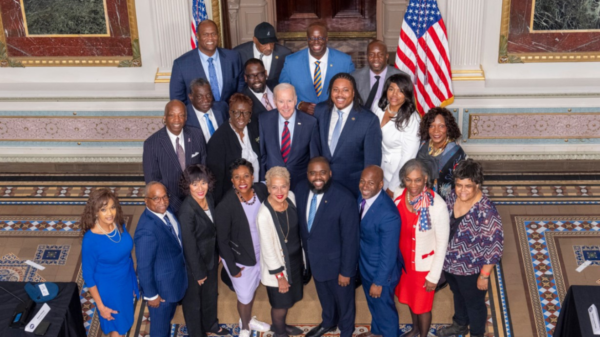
top-left (396, 0), bottom-right (454, 115)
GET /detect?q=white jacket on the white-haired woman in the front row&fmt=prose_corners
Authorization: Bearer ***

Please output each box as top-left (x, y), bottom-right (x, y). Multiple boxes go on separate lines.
top-left (256, 191), bottom-right (302, 287)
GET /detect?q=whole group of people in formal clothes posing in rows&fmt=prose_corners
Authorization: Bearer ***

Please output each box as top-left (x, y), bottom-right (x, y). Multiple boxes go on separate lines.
top-left (82, 20), bottom-right (503, 337)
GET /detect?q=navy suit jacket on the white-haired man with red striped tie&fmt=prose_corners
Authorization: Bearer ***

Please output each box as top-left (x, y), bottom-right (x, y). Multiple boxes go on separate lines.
top-left (258, 109), bottom-right (321, 189)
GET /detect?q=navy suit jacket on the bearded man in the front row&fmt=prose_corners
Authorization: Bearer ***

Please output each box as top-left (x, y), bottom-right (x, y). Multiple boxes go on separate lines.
top-left (294, 181), bottom-right (360, 282)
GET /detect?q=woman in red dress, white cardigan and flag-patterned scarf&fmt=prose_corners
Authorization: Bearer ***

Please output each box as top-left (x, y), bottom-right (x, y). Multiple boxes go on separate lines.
top-left (394, 159), bottom-right (450, 337)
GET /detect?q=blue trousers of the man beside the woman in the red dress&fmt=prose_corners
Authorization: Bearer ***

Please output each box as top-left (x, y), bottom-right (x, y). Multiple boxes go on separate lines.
top-left (362, 277), bottom-right (399, 337)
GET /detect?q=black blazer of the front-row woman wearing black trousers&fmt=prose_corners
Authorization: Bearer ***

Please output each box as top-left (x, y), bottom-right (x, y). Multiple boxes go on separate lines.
top-left (177, 193), bottom-right (217, 281)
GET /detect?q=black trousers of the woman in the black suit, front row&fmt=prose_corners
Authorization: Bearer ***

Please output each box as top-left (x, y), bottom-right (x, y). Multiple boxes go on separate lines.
top-left (181, 254), bottom-right (219, 337)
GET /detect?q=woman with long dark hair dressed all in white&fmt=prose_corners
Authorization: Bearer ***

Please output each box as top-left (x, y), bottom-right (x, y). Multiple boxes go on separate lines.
top-left (374, 73), bottom-right (421, 197)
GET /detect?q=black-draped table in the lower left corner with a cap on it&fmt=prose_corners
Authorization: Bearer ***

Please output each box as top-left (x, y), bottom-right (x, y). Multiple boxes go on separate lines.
top-left (0, 282), bottom-right (86, 337)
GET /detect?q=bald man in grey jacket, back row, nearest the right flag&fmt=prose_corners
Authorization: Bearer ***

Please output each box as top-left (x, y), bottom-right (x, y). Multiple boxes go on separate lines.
top-left (352, 40), bottom-right (402, 111)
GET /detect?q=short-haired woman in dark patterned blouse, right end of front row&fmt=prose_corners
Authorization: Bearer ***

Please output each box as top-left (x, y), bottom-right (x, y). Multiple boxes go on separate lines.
top-left (438, 159), bottom-right (504, 337)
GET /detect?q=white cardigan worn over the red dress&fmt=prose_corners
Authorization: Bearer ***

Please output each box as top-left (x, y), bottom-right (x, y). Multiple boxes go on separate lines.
top-left (394, 187), bottom-right (450, 283)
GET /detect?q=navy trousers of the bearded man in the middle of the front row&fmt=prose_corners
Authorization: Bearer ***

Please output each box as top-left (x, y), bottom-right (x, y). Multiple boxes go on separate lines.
top-left (315, 277), bottom-right (356, 337)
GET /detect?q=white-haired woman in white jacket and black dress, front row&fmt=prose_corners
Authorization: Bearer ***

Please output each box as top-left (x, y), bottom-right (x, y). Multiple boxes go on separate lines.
top-left (256, 166), bottom-right (304, 337)
